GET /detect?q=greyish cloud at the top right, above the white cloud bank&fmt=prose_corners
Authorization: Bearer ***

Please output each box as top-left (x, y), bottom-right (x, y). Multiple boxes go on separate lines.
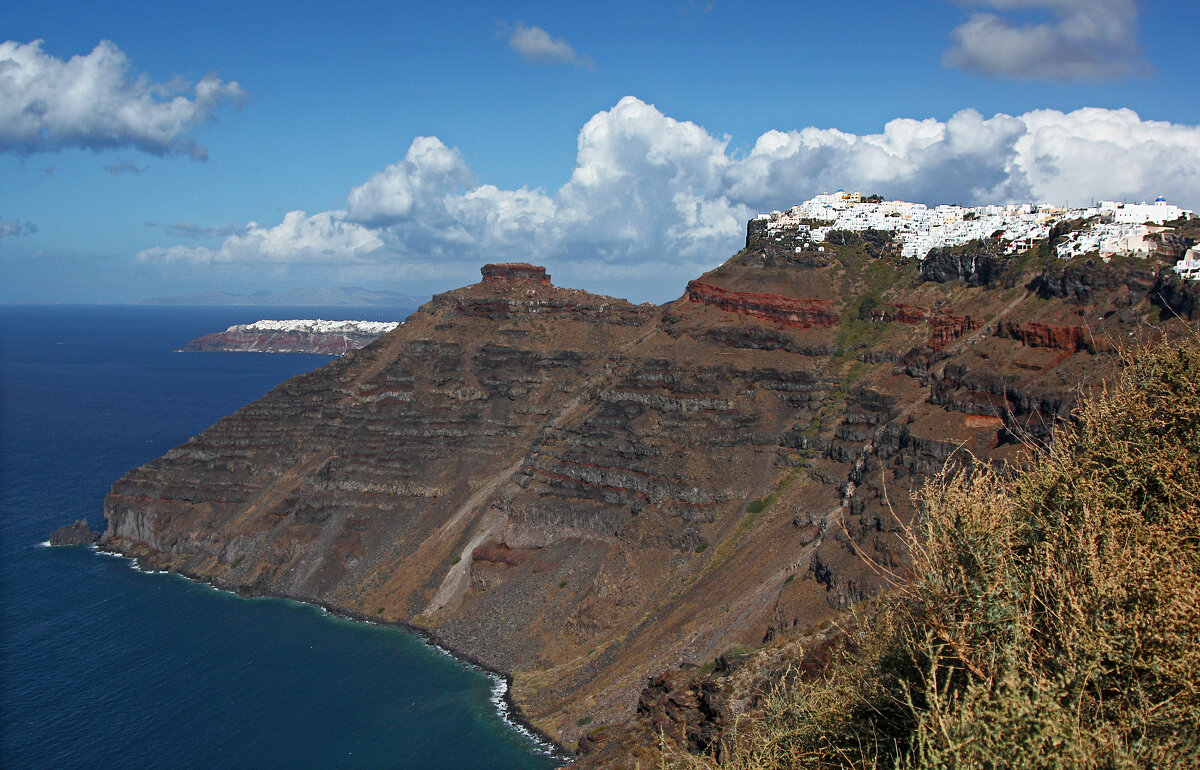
top-left (942, 0), bottom-right (1148, 82)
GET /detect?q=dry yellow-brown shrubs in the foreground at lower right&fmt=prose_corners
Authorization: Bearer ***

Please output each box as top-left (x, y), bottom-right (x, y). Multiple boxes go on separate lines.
top-left (665, 339), bottom-right (1200, 769)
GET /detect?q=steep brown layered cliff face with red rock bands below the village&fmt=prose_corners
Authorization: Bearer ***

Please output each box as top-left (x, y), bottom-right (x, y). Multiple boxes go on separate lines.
top-left (98, 237), bottom-right (1185, 745)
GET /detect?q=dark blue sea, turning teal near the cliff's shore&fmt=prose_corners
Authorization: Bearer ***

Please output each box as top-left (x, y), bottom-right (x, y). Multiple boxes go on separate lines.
top-left (0, 306), bottom-right (562, 768)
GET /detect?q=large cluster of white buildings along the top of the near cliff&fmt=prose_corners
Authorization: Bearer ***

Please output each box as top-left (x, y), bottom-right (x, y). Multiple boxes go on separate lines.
top-left (756, 190), bottom-right (1200, 279)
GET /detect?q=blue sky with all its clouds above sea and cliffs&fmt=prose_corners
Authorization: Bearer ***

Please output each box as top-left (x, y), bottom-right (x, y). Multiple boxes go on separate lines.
top-left (0, 0), bottom-right (1200, 302)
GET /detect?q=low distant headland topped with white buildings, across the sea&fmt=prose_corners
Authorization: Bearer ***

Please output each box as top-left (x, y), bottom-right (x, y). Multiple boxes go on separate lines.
top-left (178, 319), bottom-right (400, 355)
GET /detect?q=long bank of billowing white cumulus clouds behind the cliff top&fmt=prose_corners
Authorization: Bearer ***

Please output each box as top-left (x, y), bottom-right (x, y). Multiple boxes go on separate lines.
top-left (137, 96), bottom-right (1200, 297)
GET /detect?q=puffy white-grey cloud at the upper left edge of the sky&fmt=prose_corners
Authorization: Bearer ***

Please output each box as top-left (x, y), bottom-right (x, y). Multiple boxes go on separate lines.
top-left (0, 40), bottom-right (246, 160)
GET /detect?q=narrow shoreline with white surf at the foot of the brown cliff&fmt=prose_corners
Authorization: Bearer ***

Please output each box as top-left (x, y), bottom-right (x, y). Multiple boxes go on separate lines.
top-left (92, 541), bottom-right (575, 766)
